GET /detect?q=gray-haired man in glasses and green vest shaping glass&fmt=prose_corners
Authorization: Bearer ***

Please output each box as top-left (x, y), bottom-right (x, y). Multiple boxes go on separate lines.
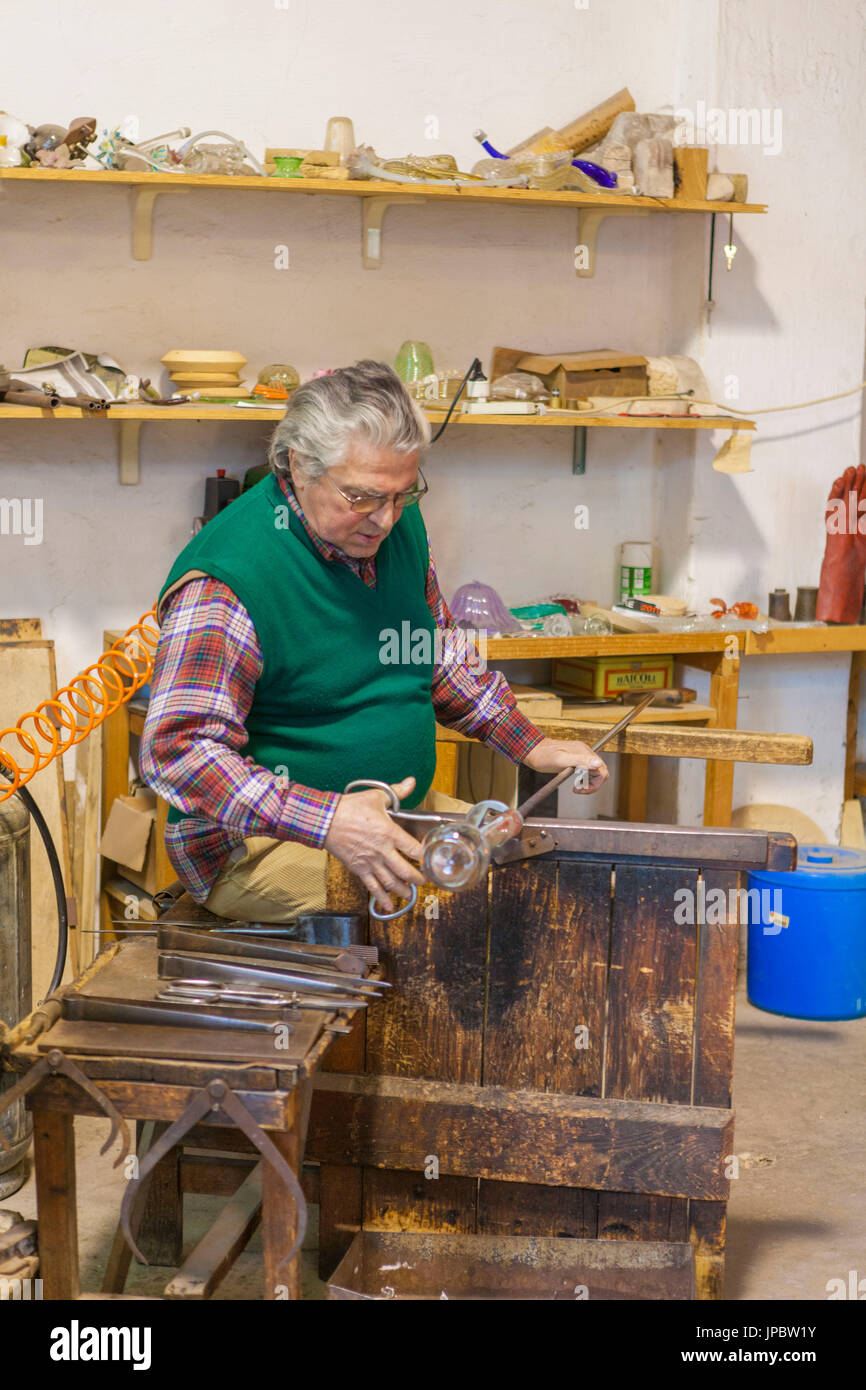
top-left (140, 361), bottom-right (607, 922)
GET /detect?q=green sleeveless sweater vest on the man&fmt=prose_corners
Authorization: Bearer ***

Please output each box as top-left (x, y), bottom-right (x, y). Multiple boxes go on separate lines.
top-left (160, 474), bottom-right (435, 821)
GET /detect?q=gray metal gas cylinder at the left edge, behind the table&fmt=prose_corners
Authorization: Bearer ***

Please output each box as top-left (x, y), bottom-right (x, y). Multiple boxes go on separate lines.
top-left (0, 796), bottom-right (32, 1202)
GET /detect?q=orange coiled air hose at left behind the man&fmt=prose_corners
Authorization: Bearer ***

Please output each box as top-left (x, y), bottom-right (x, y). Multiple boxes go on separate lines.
top-left (0, 605), bottom-right (160, 802)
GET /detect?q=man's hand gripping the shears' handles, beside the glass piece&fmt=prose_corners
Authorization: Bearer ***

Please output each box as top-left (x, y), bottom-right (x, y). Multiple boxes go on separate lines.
top-left (325, 778), bottom-right (425, 912)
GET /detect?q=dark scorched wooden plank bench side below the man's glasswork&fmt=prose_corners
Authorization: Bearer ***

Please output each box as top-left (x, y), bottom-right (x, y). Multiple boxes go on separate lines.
top-left (309, 821), bottom-right (795, 1298)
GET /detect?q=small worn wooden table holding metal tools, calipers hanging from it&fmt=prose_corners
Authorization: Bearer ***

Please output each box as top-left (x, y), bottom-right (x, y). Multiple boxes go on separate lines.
top-left (6, 934), bottom-right (343, 1300)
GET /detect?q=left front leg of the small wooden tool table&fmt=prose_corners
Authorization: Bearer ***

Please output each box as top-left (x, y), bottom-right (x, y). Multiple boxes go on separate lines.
top-left (33, 1109), bottom-right (81, 1300)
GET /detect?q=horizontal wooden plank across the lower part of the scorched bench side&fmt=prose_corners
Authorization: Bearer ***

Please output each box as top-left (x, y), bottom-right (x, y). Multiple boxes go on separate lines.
top-left (310, 1073), bottom-right (733, 1195)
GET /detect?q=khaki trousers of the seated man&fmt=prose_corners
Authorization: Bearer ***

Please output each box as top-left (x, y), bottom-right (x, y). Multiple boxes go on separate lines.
top-left (204, 791), bottom-right (468, 922)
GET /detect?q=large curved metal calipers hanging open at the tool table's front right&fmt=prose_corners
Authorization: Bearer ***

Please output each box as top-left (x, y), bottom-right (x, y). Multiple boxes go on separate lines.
top-left (121, 1077), bottom-right (307, 1265)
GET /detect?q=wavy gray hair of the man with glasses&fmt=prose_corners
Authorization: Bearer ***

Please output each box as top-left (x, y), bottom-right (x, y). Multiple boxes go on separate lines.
top-left (268, 357), bottom-right (430, 480)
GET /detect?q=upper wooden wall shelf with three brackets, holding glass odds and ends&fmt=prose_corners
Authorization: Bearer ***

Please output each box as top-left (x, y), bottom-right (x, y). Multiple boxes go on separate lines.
top-left (0, 168), bottom-right (767, 278)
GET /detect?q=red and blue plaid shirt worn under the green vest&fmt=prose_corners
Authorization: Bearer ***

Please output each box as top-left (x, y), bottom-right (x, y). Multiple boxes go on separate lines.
top-left (139, 478), bottom-right (544, 902)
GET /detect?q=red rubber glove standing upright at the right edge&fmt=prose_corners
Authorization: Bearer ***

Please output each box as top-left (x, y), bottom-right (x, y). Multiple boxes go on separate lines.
top-left (815, 463), bottom-right (866, 623)
